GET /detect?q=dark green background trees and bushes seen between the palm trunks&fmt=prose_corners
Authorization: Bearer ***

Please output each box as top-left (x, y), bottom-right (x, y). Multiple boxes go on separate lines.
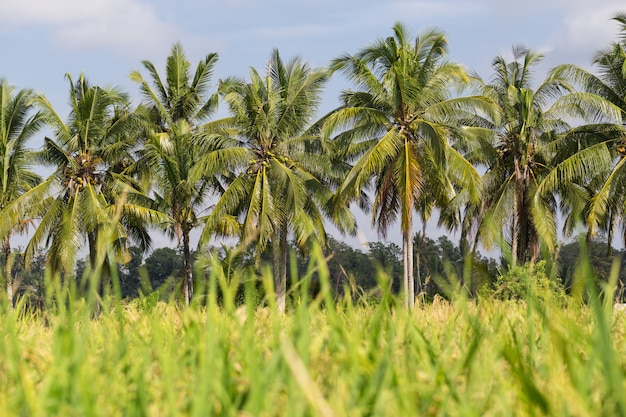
top-left (6, 232), bottom-right (626, 309)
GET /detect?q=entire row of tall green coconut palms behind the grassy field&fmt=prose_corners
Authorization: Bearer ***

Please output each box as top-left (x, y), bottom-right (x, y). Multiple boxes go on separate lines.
top-left (0, 13), bottom-right (626, 310)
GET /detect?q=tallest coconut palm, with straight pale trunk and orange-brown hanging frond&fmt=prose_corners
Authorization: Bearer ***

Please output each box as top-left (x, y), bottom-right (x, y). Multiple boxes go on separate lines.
top-left (326, 23), bottom-right (482, 308)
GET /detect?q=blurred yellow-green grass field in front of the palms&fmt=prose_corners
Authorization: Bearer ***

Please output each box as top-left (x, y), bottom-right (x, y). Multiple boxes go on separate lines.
top-left (0, 286), bottom-right (626, 417)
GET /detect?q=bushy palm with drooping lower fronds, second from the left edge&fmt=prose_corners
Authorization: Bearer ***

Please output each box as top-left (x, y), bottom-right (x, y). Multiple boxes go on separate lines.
top-left (0, 74), bottom-right (154, 288)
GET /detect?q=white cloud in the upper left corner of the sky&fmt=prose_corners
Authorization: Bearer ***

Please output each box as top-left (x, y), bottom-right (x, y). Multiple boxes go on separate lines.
top-left (0, 0), bottom-right (174, 54)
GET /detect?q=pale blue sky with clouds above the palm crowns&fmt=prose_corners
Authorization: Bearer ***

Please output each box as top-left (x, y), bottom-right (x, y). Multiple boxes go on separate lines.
top-left (0, 0), bottom-right (626, 250)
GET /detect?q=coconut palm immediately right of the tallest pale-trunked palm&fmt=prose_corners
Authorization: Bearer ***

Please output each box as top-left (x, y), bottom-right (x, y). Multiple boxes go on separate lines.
top-left (468, 46), bottom-right (615, 265)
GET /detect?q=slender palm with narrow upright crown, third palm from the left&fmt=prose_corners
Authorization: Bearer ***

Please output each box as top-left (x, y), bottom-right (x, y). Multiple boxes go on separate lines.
top-left (131, 43), bottom-right (227, 304)
